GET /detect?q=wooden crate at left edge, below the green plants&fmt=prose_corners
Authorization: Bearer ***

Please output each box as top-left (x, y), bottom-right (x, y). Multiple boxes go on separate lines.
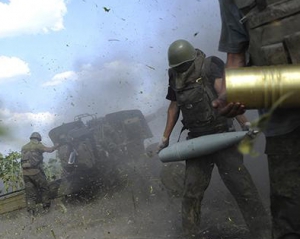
top-left (0, 190), bottom-right (26, 214)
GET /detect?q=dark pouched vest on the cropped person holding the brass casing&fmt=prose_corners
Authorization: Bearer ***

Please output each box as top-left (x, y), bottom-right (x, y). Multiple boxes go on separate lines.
top-left (235, 0), bottom-right (300, 66)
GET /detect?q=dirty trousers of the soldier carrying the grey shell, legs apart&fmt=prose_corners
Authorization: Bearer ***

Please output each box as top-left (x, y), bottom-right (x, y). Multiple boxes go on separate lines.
top-left (182, 146), bottom-right (271, 239)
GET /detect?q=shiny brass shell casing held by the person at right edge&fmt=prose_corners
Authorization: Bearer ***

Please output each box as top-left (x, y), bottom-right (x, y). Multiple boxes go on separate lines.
top-left (225, 65), bottom-right (300, 109)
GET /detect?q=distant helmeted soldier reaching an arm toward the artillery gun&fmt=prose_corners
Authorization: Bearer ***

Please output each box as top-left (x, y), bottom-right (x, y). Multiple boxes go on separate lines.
top-left (21, 132), bottom-right (59, 216)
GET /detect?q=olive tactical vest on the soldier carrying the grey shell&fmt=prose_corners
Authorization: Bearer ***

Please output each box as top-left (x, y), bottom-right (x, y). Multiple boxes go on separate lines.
top-left (169, 50), bottom-right (228, 137)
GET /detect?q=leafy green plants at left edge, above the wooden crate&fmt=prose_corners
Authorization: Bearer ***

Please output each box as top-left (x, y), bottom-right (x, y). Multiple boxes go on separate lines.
top-left (0, 152), bottom-right (24, 192)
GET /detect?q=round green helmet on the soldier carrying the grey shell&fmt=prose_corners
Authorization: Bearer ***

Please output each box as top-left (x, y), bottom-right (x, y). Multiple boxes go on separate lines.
top-left (168, 40), bottom-right (197, 67)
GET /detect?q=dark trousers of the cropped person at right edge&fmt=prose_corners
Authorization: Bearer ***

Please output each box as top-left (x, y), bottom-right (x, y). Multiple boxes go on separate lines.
top-left (266, 127), bottom-right (300, 239)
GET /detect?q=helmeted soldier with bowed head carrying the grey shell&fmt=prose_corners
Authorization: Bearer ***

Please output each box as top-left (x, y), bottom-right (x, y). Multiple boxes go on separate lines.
top-left (158, 40), bottom-right (268, 239)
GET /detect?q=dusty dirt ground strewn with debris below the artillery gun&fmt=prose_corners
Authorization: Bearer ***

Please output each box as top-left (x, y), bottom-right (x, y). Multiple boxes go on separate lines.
top-left (0, 149), bottom-right (262, 239)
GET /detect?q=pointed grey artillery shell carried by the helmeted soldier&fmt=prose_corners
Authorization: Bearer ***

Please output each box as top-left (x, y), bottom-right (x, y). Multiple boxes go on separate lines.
top-left (158, 131), bottom-right (248, 163)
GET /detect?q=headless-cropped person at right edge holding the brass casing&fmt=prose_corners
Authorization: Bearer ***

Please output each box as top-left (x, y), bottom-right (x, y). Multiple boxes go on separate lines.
top-left (214, 0), bottom-right (300, 239)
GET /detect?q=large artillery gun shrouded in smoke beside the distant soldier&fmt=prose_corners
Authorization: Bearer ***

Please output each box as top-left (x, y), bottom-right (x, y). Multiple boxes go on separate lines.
top-left (49, 110), bottom-right (153, 197)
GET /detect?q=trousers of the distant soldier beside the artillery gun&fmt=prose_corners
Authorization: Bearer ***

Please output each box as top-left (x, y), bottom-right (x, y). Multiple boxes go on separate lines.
top-left (23, 171), bottom-right (51, 211)
